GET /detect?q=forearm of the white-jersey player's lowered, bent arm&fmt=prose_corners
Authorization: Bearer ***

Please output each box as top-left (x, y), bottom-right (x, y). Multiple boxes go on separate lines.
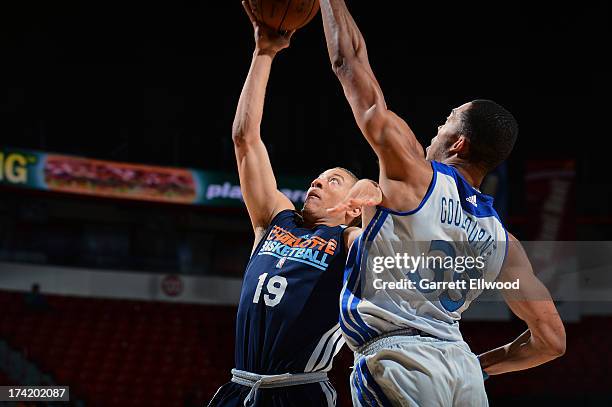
top-left (479, 330), bottom-right (562, 375)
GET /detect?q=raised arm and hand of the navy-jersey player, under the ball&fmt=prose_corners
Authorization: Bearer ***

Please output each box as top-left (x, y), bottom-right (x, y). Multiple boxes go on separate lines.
top-left (232, 1), bottom-right (294, 236)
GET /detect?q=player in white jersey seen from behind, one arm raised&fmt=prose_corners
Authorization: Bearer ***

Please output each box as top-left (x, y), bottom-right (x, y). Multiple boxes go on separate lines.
top-left (320, 0), bottom-right (565, 406)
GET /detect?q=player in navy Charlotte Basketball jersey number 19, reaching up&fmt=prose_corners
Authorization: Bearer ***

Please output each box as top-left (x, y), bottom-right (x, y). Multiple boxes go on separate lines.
top-left (209, 2), bottom-right (381, 407)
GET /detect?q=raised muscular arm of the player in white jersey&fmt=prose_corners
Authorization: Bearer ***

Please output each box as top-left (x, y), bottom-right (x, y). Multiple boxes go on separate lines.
top-left (320, 0), bottom-right (431, 194)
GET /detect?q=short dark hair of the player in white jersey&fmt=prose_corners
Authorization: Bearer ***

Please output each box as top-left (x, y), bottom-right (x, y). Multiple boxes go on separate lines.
top-left (462, 99), bottom-right (518, 171)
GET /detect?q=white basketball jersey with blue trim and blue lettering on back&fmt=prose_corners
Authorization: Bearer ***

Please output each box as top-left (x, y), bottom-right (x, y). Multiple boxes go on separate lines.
top-left (340, 161), bottom-right (508, 349)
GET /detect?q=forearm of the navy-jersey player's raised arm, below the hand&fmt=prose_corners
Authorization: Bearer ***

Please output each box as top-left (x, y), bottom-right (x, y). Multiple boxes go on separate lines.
top-left (232, 49), bottom-right (274, 143)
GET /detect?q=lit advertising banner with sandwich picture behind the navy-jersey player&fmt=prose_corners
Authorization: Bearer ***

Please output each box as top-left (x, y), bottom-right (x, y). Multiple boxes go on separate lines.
top-left (0, 148), bottom-right (310, 208)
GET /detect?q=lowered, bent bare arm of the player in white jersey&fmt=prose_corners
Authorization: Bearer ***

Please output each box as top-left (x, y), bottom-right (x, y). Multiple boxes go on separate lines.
top-left (480, 235), bottom-right (565, 375)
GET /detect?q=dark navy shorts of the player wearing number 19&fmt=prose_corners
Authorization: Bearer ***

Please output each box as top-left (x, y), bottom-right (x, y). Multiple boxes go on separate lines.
top-left (208, 381), bottom-right (336, 407)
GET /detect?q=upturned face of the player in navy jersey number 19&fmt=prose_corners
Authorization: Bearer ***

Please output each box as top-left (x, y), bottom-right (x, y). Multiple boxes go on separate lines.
top-left (304, 168), bottom-right (355, 218)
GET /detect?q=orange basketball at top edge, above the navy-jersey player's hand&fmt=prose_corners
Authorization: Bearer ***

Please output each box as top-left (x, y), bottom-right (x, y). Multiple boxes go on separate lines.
top-left (249, 0), bottom-right (319, 31)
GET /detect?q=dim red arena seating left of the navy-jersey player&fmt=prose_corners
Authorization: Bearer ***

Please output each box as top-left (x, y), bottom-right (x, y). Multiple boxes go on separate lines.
top-left (0, 292), bottom-right (235, 407)
